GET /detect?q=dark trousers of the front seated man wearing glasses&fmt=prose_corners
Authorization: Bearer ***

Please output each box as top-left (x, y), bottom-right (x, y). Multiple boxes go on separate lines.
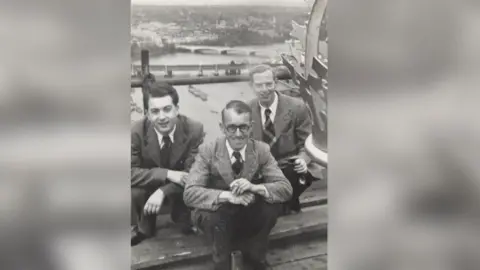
top-left (194, 197), bottom-right (281, 270)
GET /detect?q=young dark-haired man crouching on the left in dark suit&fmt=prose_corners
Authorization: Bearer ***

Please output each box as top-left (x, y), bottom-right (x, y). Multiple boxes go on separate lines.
top-left (131, 83), bottom-right (204, 245)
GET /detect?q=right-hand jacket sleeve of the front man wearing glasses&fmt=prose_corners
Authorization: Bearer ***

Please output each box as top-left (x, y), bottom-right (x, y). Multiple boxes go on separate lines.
top-left (259, 147), bottom-right (293, 203)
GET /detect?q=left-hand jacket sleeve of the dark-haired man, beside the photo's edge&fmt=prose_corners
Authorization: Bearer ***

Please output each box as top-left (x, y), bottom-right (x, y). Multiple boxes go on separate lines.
top-left (130, 131), bottom-right (171, 188)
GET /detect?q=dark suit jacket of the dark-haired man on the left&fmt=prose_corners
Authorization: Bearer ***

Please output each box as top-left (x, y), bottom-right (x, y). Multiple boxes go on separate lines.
top-left (131, 115), bottom-right (205, 195)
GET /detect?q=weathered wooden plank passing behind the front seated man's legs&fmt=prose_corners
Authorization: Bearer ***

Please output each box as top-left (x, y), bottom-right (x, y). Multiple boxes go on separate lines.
top-left (132, 205), bottom-right (328, 269)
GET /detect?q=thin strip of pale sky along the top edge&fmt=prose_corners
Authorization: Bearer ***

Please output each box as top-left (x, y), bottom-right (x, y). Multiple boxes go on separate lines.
top-left (131, 0), bottom-right (306, 6)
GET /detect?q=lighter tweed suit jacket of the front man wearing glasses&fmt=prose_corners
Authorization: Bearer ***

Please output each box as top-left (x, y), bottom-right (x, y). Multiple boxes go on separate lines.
top-left (183, 137), bottom-right (292, 211)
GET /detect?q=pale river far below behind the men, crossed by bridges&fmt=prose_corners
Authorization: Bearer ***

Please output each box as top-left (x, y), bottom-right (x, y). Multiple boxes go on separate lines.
top-left (132, 43), bottom-right (289, 141)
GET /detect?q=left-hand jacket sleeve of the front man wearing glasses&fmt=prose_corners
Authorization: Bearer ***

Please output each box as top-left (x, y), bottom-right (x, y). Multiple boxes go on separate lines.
top-left (183, 144), bottom-right (222, 211)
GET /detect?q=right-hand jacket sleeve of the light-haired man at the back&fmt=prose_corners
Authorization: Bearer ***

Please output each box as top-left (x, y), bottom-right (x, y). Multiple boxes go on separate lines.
top-left (295, 104), bottom-right (312, 164)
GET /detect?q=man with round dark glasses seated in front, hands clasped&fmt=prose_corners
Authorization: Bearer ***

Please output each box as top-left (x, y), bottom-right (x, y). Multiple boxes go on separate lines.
top-left (183, 100), bottom-right (292, 270)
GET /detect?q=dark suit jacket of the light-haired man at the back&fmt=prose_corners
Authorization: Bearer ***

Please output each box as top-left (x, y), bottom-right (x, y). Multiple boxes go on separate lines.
top-left (249, 92), bottom-right (322, 178)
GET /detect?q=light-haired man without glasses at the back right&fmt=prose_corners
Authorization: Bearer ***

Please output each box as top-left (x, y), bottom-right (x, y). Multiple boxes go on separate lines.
top-left (249, 65), bottom-right (321, 214)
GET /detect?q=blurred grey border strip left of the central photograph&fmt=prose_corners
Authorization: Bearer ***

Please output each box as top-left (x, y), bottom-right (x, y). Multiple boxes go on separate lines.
top-left (0, 0), bottom-right (130, 270)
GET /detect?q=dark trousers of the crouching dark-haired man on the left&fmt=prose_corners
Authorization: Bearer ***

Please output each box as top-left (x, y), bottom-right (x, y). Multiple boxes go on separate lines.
top-left (130, 188), bottom-right (190, 236)
